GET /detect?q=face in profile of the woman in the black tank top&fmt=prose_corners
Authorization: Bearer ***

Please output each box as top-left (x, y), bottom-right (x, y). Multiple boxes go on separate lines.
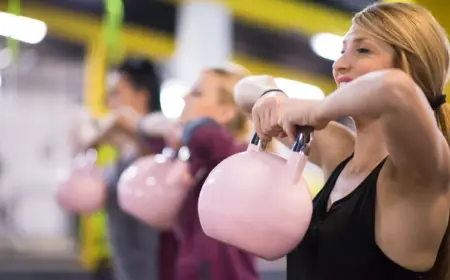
top-left (333, 25), bottom-right (395, 87)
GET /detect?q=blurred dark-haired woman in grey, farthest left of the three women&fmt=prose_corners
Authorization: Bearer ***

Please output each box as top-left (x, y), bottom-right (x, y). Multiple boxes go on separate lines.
top-left (93, 59), bottom-right (176, 280)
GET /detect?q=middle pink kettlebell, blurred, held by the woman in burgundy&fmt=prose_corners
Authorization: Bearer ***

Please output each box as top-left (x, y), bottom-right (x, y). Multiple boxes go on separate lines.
top-left (118, 148), bottom-right (192, 230)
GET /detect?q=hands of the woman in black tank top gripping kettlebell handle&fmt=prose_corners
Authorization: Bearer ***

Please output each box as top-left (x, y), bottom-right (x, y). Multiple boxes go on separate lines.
top-left (252, 95), bottom-right (331, 141)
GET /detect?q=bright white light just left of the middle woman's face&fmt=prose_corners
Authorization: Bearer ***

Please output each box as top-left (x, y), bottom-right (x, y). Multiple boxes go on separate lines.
top-left (160, 80), bottom-right (188, 119)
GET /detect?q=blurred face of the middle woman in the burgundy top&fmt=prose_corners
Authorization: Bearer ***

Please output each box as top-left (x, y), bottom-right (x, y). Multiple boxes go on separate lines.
top-left (180, 71), bottom-right (236, 124)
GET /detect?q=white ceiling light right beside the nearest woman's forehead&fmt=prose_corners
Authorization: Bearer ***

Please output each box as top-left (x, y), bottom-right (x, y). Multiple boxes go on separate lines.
top-left (310, 33), bottom-right (344, 61)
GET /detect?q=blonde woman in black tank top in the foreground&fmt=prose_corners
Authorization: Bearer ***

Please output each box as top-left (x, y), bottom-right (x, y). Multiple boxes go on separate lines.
top-left (239, 3), bottom-right (450, 280)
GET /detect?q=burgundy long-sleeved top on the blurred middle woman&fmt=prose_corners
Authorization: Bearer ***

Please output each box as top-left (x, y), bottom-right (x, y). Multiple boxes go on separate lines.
top-left (175, 121), bottom-right (259, 280)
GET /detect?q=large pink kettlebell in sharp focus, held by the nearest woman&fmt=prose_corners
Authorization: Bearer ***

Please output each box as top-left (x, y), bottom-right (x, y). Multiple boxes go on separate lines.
top-left (198, 129), bottom-right (312, 260)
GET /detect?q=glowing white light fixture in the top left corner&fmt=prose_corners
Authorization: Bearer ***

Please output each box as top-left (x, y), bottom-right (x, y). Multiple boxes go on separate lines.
top-left (0, 12), bottom-right (47, 44)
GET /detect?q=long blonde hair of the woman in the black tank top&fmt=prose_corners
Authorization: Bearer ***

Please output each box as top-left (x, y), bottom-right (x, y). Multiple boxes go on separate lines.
top-left (353, 3), bottom-right (450, 280)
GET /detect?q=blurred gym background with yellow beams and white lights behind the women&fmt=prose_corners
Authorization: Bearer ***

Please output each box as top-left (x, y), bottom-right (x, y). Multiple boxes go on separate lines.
top-left (0, 0), bottom-right (450, 280)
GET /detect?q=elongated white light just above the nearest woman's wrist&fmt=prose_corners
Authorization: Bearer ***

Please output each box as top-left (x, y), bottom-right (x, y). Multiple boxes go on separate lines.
top-left (275, 78), bottom-right (325, 100)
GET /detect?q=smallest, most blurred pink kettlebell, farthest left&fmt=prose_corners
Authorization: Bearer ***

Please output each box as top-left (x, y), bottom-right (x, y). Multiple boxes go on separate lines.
top-left (56, 150), bottom-right (106, 214)
